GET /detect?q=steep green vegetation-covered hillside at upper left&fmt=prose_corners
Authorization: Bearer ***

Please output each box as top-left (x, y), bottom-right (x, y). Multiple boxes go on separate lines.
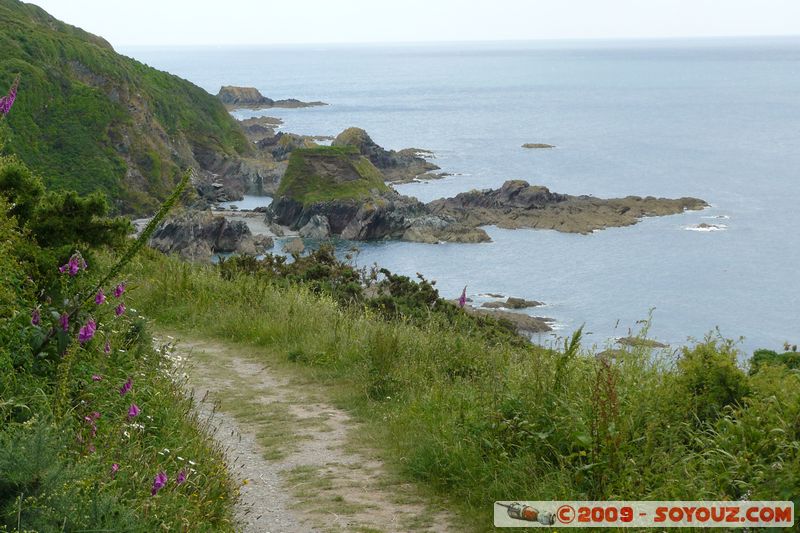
top-left (0, 0), bottom-right (250, 212)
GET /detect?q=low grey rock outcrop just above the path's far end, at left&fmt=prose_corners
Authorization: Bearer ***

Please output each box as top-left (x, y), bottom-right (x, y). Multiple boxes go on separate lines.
top-left (149, 210), bottom-right (273, 262)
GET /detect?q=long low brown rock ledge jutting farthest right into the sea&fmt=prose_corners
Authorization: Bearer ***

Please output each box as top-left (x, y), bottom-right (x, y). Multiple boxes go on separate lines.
top-left (428, 180), bottom-right (708, 233)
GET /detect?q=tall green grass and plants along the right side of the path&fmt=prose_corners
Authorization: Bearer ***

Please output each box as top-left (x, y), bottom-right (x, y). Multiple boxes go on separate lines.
top-left (130, 249), bottom-right (800, 524)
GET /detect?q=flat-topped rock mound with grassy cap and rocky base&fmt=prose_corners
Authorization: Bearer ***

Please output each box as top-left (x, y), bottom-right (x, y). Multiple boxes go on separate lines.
top-left (267, 147), bottom-right (489, 242)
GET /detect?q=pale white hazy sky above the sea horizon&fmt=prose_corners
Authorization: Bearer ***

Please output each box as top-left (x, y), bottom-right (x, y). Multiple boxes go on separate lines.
top-left (33, 0), bottom-right (800, 46)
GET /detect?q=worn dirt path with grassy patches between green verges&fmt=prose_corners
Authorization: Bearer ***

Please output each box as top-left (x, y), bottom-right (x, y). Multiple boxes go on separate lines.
top-left (167, 335), bottom-right (450, 533)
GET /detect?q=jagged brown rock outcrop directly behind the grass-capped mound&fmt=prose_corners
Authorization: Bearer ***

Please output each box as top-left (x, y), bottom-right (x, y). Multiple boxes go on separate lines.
top-left (332, 128), bottom-right (441, 183)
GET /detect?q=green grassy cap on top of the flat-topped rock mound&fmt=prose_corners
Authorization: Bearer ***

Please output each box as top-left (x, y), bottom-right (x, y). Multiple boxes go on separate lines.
top-left (277, 146), bottom-right (389, 205)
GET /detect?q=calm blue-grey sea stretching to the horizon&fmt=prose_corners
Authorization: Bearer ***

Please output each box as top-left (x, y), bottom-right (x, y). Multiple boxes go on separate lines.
top-left (122, 39), bottom-right (800, 351)
